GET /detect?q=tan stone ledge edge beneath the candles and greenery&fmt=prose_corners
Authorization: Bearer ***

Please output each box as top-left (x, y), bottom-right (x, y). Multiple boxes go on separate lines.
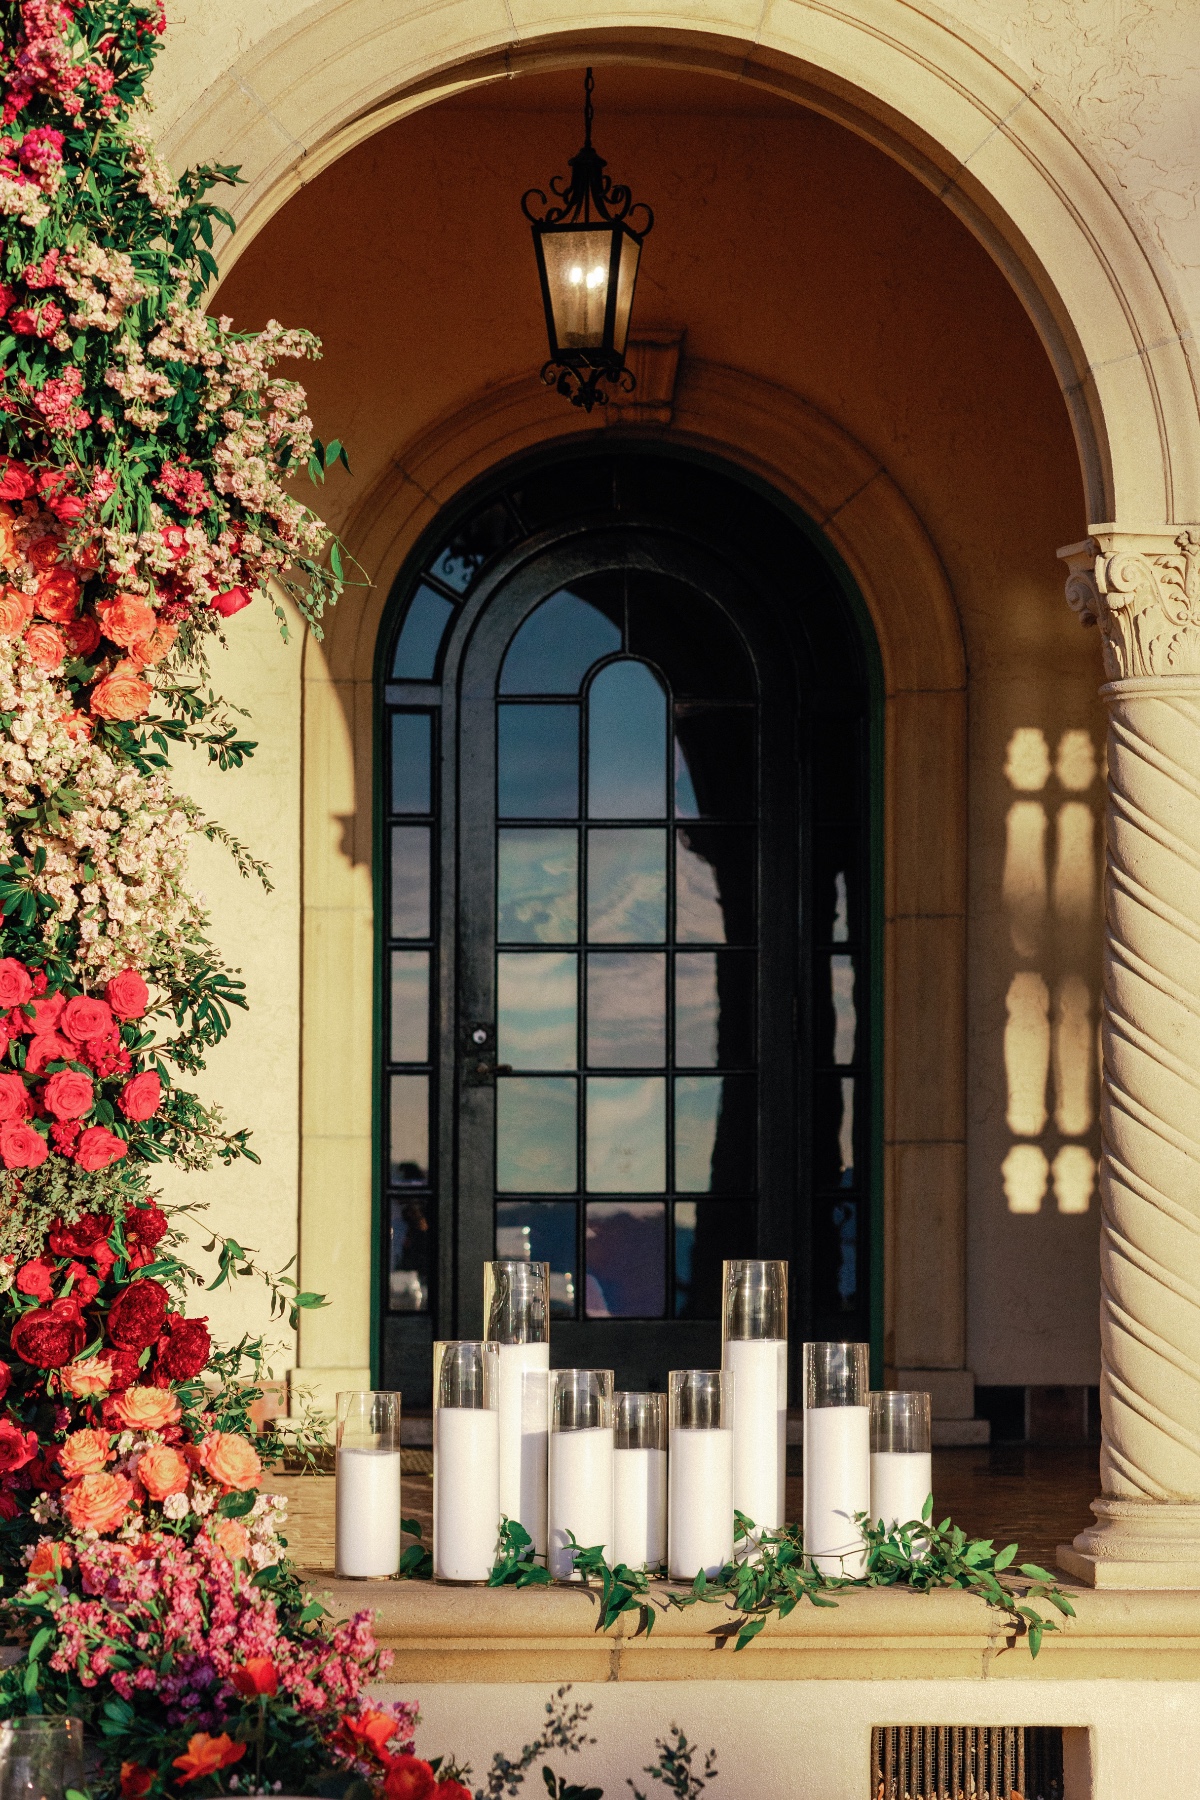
top-left (304, 1570), bottom-right (1200, 1683)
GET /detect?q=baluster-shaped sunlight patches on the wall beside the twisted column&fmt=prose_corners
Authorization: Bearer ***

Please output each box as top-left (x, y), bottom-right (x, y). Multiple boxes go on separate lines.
top-left (1002, 725), bottom-right (1099, 1213)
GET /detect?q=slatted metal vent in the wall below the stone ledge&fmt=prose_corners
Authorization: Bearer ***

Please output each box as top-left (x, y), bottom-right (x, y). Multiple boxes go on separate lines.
top-left (871, 1724), bottom-right (1063, 1800)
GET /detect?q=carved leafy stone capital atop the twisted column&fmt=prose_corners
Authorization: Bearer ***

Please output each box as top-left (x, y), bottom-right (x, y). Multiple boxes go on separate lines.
top-left (1058, 526), bottom-right (1200, 680)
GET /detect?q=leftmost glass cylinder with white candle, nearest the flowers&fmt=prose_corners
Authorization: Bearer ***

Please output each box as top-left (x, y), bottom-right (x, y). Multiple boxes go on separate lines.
top-left (333, 1388), bottom-right (401, 1580)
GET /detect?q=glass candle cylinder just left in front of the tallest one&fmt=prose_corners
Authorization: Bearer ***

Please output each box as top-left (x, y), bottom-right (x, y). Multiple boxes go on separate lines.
top-left (667, 1368), bottom-right (736, 1580)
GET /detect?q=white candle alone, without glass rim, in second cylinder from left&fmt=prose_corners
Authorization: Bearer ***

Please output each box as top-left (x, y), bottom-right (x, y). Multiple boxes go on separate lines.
top-left (434, 1406), bottom-right (500, 1580)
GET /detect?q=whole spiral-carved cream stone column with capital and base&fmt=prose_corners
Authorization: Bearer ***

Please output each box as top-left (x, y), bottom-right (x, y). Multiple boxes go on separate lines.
top-left (1058, 527), bottom-right (1200, 1588)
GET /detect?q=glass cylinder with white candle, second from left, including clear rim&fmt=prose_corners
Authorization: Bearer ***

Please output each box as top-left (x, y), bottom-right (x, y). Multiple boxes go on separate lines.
top-left (434, 1339), bottom-right (500, 1582)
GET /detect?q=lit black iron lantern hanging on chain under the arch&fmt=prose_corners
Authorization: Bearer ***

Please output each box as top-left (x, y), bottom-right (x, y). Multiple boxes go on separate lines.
top-left (522, 68), bottom-right (655, 412)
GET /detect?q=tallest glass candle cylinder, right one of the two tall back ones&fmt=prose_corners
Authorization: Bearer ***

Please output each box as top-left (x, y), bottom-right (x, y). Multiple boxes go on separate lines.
top-left (721, 1258), bottom-right (788, 1532)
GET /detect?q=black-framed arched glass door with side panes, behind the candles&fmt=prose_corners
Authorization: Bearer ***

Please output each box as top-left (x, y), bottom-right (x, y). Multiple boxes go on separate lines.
top-left (376, 446), bottom-right (880, 1395)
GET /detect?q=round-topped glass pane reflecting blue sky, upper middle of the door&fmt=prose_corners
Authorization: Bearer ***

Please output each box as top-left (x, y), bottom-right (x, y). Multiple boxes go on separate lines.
top-left (588, 662), bottom-right (667, 819)
